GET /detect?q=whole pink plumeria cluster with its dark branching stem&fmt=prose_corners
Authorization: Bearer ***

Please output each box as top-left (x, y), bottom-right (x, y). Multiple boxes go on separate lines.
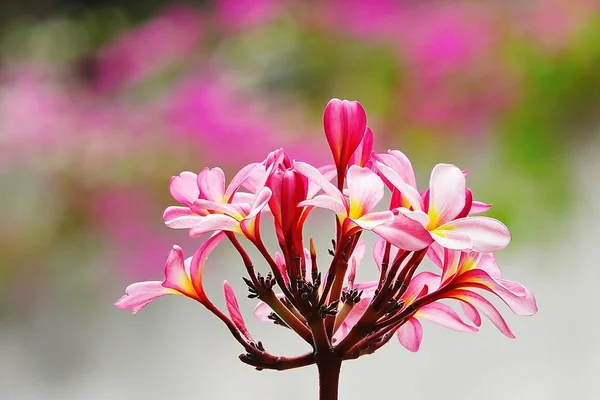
top-left (116, 99), bottom-right (537, 398)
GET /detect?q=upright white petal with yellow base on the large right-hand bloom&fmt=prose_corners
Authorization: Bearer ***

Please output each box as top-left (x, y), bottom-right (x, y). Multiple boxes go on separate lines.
top-left (427, 164), bottom-right (467, 229)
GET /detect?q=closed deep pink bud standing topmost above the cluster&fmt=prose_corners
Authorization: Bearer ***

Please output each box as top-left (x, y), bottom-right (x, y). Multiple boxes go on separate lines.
top-left (323, 99), bottom-right (367, 172)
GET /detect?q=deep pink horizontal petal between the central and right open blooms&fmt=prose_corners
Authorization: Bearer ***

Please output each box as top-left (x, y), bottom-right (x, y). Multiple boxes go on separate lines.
top-left (372, 215), bottom-right (433, 251)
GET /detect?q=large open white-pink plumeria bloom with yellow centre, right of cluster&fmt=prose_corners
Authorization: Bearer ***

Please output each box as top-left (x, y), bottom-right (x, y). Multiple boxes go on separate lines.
top-left (376, 151), bottom-right (510, 252)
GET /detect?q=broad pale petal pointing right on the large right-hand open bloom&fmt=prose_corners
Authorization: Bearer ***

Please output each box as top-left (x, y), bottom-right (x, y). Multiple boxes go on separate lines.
top-left (436, 217), bottom-right (510, 253)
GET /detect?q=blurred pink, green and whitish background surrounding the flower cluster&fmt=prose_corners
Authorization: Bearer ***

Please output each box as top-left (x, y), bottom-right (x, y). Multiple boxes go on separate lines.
top-left (0, 0), bottom-right (600, 400)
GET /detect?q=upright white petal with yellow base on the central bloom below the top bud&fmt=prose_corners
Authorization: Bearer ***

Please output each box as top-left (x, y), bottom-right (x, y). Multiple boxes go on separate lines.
top-left (346, 165), bottom-right (384, 218)
